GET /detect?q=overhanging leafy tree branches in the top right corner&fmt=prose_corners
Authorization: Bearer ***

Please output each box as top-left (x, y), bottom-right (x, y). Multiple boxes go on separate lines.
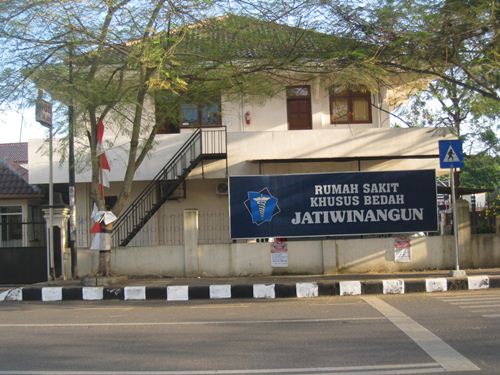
top-left (320, 0), bottom-right (500, 101)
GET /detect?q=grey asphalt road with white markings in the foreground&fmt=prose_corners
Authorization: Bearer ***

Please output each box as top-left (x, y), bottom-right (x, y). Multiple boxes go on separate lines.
top-left (0, 290), bottom-right (500, 375)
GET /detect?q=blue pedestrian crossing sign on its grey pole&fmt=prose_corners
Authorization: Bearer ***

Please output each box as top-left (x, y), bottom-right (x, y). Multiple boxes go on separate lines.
top-left (439, 139), bottom-right (466, 277)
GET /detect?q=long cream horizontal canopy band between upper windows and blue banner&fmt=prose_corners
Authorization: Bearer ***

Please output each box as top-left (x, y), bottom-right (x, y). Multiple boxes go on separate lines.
top-left (29, 128), bottom-right (446, 184)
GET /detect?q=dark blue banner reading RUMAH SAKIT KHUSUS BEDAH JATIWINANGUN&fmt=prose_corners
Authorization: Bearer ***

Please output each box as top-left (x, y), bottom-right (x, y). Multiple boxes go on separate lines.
top-left (229, 170), bottom-right (437, 239)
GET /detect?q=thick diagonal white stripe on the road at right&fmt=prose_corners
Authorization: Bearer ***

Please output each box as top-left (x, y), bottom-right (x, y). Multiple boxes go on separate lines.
top-left (361, 296), bottom-right (480, 371)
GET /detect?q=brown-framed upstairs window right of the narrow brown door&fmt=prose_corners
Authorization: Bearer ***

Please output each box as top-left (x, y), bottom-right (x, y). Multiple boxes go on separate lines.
top-left (330, 89), bottom-right (372, 124)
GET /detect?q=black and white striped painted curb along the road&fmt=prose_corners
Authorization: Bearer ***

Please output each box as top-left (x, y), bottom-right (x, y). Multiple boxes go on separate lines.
top-left (0, 276), bottom-right (500, 302)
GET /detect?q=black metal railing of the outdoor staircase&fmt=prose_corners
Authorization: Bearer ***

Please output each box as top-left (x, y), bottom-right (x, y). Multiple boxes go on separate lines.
top-left (112, 128), bottom-right (227, 247)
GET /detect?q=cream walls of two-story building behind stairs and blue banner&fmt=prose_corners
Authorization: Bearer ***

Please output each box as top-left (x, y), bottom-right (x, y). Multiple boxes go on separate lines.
top-left (29, 15), bottom-right (458, 275)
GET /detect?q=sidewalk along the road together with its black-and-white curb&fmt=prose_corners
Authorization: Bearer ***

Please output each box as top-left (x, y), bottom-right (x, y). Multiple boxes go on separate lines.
top-left (0, 268), bottom-right (500, 302)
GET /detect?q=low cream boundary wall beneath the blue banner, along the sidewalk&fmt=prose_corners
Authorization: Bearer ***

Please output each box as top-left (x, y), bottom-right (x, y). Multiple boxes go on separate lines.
top-left (78, 234), bottom-right (500, 277)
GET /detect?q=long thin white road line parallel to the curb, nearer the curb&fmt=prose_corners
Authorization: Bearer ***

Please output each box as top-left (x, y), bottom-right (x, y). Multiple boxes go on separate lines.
top-left (0, 317), bottom-right (384, 328)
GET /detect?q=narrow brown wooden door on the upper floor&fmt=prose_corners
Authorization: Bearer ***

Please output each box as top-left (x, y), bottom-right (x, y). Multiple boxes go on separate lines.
top-left (286, 86), bottom-right (312, 130)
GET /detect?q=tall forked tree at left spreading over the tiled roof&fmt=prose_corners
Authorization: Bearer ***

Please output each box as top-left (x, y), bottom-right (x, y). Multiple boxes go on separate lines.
top-left (0, 0), bottom-right (382, 274)
